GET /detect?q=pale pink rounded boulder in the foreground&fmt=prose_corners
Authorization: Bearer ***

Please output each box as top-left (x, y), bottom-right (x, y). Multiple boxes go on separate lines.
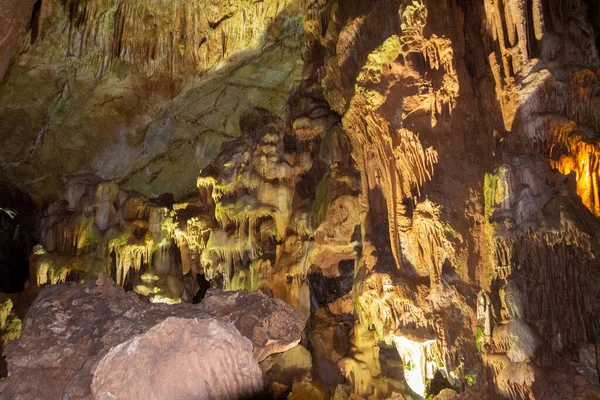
top-left (92, 317), bottom-right (263, 400)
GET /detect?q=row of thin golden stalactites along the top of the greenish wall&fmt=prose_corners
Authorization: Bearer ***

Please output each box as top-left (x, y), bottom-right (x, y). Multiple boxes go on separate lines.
top-left (34, 0), bottom-right (298, 76)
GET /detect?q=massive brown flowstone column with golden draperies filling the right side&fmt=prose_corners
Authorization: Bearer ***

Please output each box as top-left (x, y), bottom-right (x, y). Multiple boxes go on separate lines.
top-left (305, 1), bottom-right (599, 398)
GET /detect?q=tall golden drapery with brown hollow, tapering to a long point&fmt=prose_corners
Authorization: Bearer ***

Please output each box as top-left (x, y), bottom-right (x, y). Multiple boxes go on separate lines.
top-left (343, 2), bottom-right (458, 268)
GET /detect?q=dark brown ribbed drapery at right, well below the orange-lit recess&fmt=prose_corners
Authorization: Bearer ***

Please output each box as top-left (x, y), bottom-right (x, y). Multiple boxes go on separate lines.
top-left (512, 230), bottom-right (600, 350)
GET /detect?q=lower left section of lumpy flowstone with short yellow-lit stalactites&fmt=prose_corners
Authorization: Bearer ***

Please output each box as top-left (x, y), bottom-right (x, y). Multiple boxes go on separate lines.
top-left (30, 175), bottom-right (183, 302)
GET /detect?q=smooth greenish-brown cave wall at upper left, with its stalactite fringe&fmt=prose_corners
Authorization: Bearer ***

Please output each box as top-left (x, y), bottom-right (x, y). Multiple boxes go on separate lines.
top-left (0, 0), bottom-right (303, 203)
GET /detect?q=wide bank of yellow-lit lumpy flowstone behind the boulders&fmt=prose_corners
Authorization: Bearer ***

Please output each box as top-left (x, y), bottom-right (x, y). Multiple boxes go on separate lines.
top-left (30, 108), bottom-right (359, 315)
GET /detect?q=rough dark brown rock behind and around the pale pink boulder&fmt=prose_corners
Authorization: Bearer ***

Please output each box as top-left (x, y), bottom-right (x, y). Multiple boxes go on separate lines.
top-left (2, 277), bottom-right (304, 400)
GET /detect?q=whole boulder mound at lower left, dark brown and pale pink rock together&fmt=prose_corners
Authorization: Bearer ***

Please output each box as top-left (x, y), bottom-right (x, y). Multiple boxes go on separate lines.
top-left (1, 276), bottom-right (305, 400)
